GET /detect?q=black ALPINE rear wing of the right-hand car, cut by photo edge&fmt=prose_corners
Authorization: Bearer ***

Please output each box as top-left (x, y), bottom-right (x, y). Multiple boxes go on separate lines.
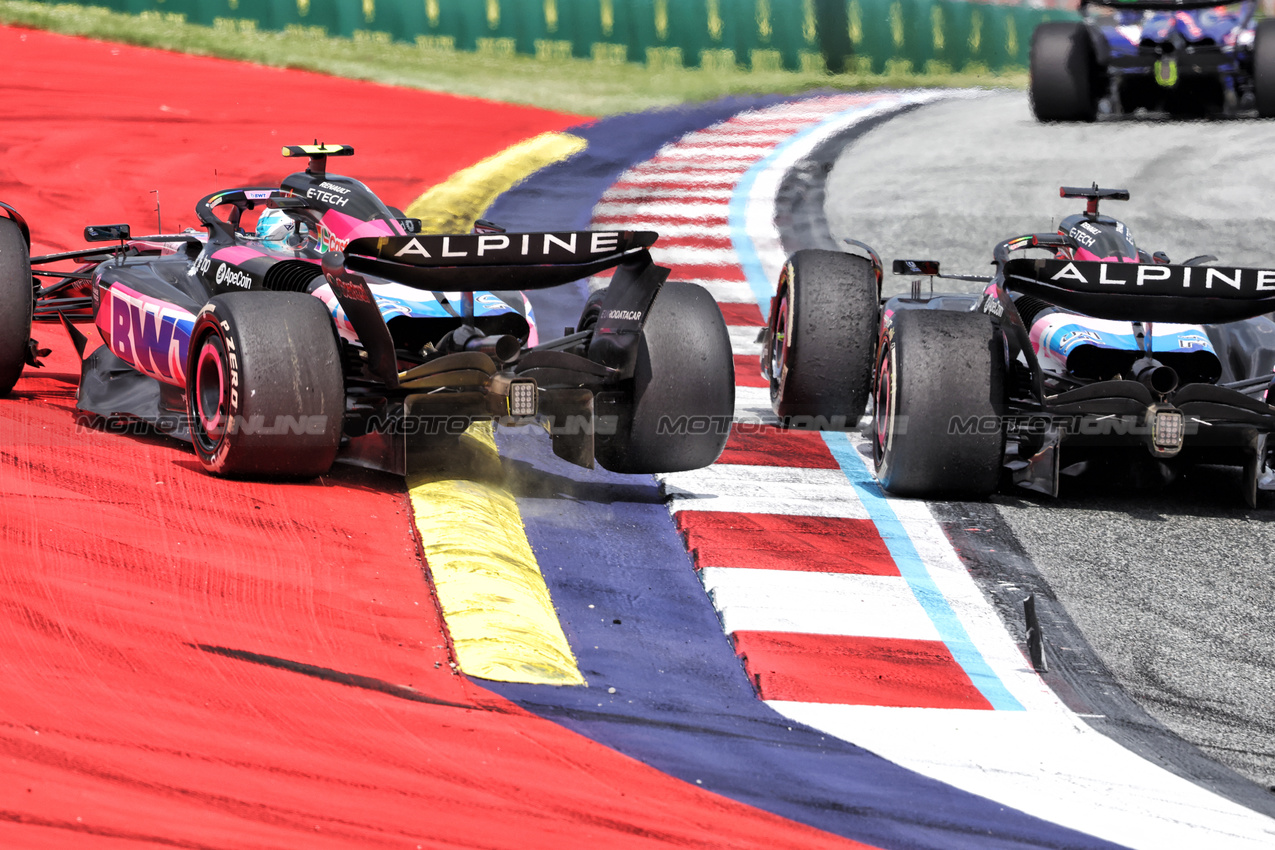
top-left (1005, 259), bottom-right (1275, 325)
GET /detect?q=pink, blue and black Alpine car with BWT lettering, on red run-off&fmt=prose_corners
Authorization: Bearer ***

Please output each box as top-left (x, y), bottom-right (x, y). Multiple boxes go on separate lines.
top-left (0, 143), bottom-right (734, 478)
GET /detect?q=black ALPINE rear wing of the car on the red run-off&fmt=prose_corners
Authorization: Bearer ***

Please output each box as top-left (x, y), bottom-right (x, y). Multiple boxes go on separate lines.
top-left (344, 231), bottom-right (659, 292)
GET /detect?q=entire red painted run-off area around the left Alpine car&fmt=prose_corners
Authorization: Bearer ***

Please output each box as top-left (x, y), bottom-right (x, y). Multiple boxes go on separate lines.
top-left (0, 28), bottom-right (882, 849)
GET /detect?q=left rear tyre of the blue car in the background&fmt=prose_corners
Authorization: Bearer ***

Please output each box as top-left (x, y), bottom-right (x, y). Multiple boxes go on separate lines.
top-left (1028, 20), bottom-right (1103, 121)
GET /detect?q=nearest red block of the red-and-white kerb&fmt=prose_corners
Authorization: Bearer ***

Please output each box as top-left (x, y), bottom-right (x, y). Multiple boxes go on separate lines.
top-left (734, 631), bottom-right (992, 710)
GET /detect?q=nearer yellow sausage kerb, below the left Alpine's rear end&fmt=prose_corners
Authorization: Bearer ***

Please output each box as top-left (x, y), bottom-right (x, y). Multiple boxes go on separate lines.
top-left (407, 422), bottom-right (585, 684)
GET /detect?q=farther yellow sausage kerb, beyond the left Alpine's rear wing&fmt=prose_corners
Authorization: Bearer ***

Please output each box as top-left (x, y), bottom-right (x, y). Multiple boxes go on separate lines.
top-left (405, 133), bottom-right (588, 233)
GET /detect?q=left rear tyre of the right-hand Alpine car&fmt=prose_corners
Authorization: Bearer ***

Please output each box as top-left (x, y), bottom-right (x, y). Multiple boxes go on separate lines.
top-left (872, 310), bottom-right (1005, 498)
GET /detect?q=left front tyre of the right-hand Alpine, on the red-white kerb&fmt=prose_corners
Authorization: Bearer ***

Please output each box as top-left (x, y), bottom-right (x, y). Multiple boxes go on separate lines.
top-left (761, 250), bottom-right (880, 429)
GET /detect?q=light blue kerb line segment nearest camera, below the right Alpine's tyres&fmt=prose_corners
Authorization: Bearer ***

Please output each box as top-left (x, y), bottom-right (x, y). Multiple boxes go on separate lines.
top-left (824, 431), bottom-right (1024, 711)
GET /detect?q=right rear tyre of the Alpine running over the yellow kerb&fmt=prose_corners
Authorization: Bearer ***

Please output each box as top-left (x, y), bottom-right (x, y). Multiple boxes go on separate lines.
top-left (594, 282), bottom-right (734, 473)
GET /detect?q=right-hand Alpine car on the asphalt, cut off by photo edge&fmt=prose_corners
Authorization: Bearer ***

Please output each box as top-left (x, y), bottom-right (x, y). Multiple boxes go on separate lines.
top-left (761, 185), bottom-right (1275, 506)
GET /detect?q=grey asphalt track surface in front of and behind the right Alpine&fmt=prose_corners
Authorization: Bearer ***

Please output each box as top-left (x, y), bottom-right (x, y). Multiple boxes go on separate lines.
top-left (825, 87), bottom-right (1275, 789)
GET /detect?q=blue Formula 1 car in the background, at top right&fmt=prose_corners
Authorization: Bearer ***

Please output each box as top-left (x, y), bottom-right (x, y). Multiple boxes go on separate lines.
top-left (1030, 0), bottom-right (1275, 121)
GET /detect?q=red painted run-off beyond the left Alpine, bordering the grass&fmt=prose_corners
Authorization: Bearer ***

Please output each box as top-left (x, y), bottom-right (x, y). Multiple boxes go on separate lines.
top-left (0, 27), bottom-right (585, 254)
